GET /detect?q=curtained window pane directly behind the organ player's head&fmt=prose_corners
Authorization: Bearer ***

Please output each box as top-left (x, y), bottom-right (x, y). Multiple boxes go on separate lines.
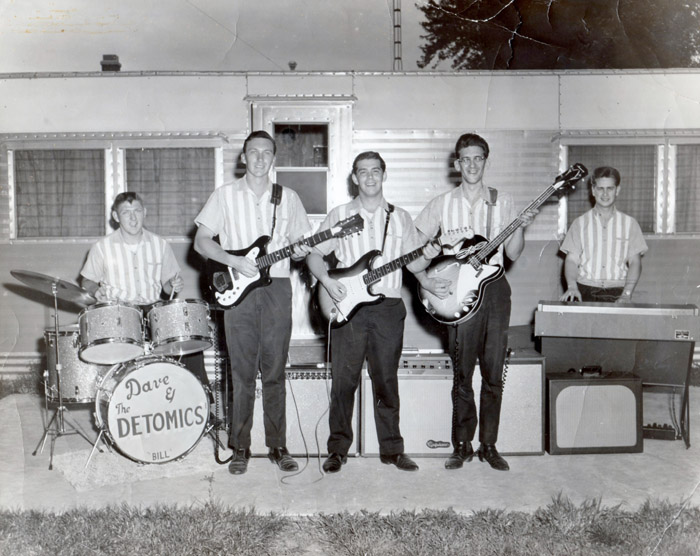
top-left (567, 145), bottom-right (657, 233)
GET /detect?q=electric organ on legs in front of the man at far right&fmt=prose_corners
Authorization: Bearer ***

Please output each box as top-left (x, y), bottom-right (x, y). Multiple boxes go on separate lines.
top-left (535, 301), bottom-right (700, 447)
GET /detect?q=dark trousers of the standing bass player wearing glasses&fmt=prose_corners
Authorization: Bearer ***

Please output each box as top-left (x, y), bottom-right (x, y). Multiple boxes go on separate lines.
top-left (448, 277), bottom-right (511, 446)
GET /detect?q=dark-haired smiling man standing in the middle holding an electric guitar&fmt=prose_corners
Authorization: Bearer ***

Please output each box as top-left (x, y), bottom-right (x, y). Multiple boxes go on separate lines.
top-left (306, 152), bottom-right (439, 473)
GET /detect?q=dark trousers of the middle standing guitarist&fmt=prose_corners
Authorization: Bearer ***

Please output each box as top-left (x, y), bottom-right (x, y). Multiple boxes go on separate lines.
top-left (328, 298), bottom-right (406, 455)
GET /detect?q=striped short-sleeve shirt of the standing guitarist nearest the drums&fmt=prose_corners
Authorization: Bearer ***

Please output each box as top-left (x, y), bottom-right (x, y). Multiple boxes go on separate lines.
top-left (195, 177), bottom-right (311, 278)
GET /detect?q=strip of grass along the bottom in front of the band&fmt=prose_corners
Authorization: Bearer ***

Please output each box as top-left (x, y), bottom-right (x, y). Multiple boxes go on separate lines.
top-left (0, 497), bottom-right (700, 556)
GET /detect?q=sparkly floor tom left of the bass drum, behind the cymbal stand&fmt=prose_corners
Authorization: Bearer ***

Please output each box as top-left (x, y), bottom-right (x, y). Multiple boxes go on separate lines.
top-left (44, 324), bottom-right (109, 403)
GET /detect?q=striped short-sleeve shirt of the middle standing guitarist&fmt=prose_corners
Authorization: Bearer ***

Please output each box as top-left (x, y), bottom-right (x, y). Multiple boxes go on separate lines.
top-left (315, 198), bottom-right (422, 298)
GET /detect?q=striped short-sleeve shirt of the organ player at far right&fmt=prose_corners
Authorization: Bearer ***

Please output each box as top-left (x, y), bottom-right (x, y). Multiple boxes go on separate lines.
top-left (560, 208), bottom-right (647, 288)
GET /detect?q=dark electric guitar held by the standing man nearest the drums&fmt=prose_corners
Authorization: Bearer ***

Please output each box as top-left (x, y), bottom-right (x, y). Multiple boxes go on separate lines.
top-left (207, 214), bottom-right (365, 308)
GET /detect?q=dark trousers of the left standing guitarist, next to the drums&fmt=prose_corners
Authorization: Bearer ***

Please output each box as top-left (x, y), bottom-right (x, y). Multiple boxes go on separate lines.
top-left (224, 278), bottom-right (292, 449)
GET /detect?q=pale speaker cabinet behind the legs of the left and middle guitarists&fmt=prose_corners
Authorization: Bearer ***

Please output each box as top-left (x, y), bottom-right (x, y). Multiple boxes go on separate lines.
top-left (250, 365), bottom-right (360, 457)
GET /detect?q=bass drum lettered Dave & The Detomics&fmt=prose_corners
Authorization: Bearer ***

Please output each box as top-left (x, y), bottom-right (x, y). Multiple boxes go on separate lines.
top-left (95, 355), bottom-right (209, 463)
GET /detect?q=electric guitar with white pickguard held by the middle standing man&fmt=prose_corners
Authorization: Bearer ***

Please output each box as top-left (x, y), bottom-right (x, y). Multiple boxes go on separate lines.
top-left (316, 230), bottom-right (464, 326)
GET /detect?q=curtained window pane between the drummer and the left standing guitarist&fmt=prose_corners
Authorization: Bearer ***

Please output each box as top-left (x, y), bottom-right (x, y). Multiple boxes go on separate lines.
top-left (125, 148), bottom-right (215, 236)
